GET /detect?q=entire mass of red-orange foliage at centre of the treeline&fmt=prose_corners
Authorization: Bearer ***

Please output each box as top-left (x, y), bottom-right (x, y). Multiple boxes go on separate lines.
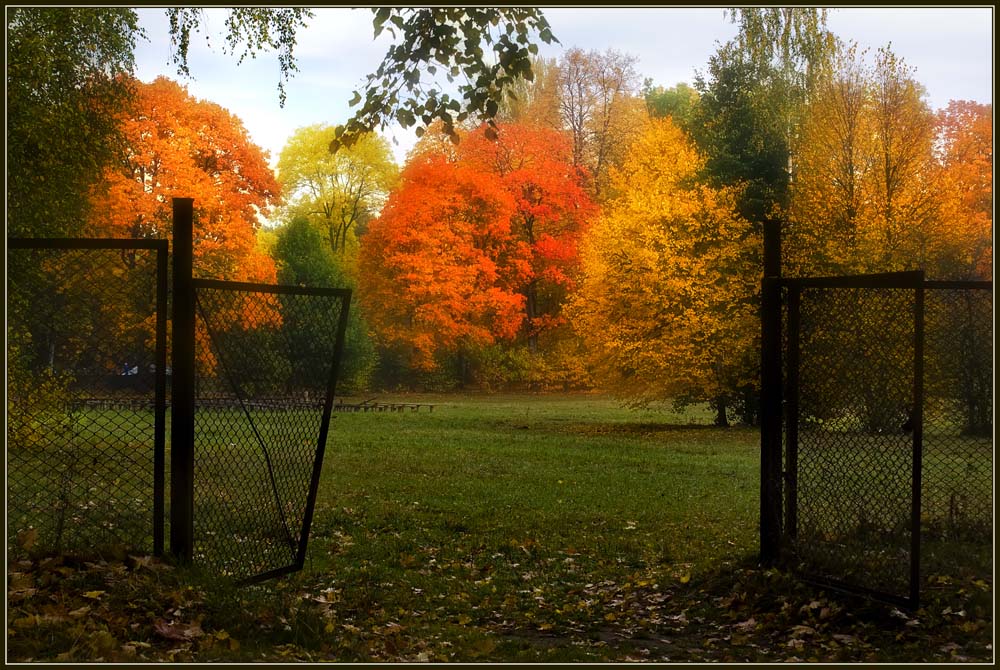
top-left (359, 125), bottom-right (594, 369)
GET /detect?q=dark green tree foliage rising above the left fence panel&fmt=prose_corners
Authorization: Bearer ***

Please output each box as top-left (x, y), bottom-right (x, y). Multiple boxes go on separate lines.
top-left (6, 7), bottom-right (142, 237)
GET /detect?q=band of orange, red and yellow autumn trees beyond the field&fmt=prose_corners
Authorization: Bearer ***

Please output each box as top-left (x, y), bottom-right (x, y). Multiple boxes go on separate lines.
top-left (12, 8), bottom-right (992, 423)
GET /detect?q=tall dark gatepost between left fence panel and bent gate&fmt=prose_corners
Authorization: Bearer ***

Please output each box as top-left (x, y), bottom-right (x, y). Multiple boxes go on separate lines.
top-left (170, 198), bottom-right (194, 562)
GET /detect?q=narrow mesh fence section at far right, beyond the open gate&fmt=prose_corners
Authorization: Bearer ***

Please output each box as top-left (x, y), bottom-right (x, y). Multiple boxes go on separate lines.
top-left (921, 282), bottom-right (993, 576)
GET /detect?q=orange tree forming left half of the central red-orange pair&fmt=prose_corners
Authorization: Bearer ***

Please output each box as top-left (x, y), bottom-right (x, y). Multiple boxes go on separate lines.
top-left (359, 154), bottom-right (531, 380)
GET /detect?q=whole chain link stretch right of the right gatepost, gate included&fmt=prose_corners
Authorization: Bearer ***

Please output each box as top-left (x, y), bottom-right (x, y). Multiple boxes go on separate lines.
top-left (780, 275), bottom-right (993, 605)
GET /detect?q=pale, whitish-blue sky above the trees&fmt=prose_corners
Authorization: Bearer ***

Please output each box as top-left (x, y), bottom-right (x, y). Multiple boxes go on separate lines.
top-left (136, 7), bottom-right (993, 165)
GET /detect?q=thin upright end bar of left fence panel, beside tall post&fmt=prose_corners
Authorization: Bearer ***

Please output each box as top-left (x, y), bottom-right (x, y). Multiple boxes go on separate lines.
top-left (153, 241), bottom-right (168, 556)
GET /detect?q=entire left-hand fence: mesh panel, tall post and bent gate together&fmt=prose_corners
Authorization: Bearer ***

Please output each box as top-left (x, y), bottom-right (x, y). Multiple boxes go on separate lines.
top-left (7, 198), bottom-right (351, 581)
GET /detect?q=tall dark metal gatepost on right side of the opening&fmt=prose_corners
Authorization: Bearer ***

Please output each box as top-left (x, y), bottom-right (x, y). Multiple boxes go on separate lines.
top-left (760, 220), bottom-right (781, 564)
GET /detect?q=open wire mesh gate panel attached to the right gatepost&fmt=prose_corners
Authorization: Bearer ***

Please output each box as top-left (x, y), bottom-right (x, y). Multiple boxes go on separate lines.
top-left (785, 286), bottom-right (919, 602)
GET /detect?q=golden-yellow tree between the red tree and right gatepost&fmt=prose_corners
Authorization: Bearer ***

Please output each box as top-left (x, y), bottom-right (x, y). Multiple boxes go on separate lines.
top-left (567, 118), bottom-right (759, 425)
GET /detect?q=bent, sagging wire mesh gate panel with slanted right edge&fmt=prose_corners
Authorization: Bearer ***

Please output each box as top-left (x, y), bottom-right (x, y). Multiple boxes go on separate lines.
top-left (194, 280), bottom-right (350, 580)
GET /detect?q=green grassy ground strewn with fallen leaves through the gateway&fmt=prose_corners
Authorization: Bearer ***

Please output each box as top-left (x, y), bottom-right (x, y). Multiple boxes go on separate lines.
top-left (8, 395), bottom-right (992, 662)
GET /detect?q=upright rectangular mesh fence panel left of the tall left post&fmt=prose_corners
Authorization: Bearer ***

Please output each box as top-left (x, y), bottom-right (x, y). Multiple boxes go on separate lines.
top-left (7, 240), bottom-right (166, 556)
